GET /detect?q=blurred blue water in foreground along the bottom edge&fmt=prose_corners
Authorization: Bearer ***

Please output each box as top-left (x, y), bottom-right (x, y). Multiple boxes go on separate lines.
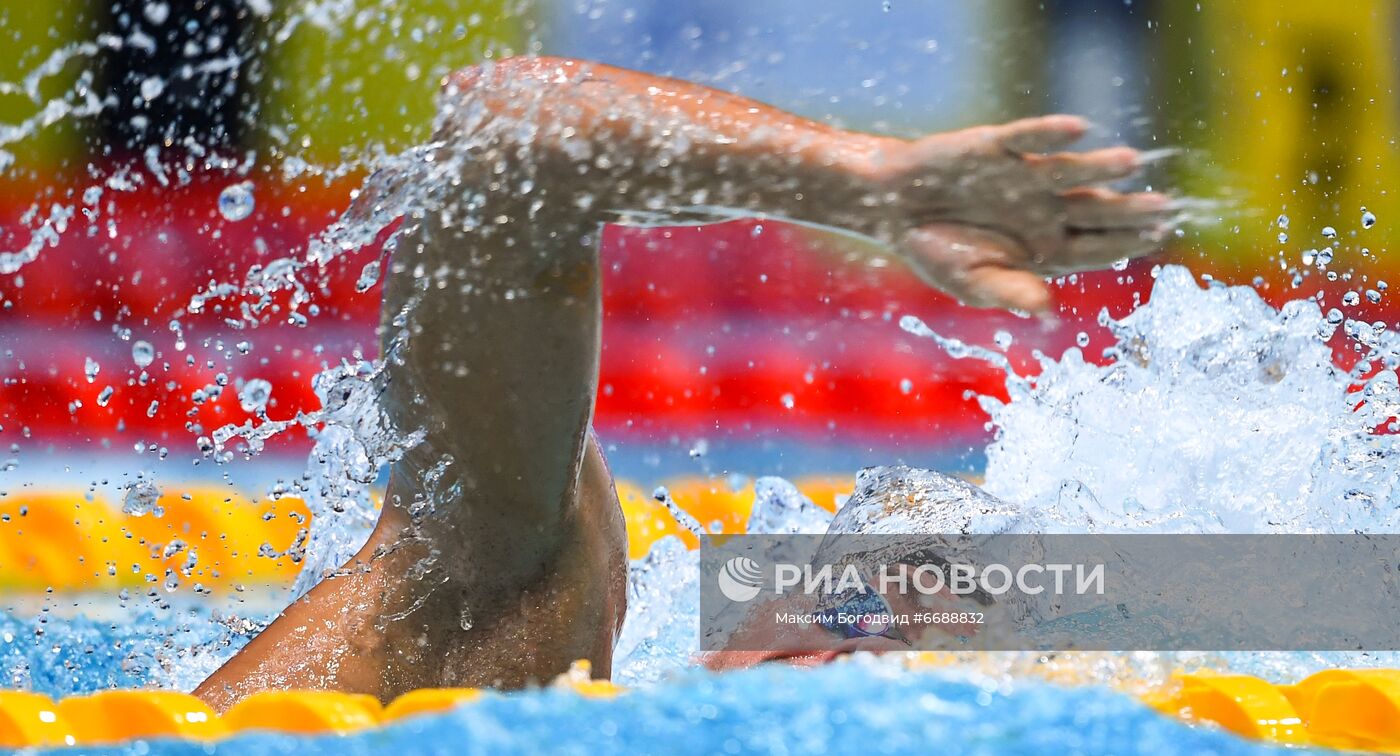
top-left (40, 659), bottom-right (1273, 756)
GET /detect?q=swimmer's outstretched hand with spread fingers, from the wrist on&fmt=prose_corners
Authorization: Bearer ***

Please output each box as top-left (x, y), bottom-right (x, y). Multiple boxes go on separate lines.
top-left (862, 115), bottom-right (1175, 312)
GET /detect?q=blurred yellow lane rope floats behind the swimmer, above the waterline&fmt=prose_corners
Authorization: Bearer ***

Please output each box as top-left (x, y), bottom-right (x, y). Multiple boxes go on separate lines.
top-left (0, 476), bottom-right (854, 591)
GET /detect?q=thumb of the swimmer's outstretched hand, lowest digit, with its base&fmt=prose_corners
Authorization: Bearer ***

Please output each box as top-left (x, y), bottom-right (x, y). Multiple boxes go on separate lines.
top-left (902, 224), bottom-right (1050, 312)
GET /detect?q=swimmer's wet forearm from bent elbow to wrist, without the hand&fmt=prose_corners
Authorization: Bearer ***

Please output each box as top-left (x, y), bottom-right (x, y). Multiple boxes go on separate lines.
top-left (436, 57), bottom-right (902, 241)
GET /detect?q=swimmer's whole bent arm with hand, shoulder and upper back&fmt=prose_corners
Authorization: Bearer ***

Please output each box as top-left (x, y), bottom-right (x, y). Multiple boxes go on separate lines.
top-left (196, 57), bottom-right (1175, 710)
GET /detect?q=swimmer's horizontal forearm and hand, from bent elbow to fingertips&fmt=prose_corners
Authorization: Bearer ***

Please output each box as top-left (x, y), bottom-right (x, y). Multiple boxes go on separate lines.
top-left (440, 57), bottom-right (1175, 309)
